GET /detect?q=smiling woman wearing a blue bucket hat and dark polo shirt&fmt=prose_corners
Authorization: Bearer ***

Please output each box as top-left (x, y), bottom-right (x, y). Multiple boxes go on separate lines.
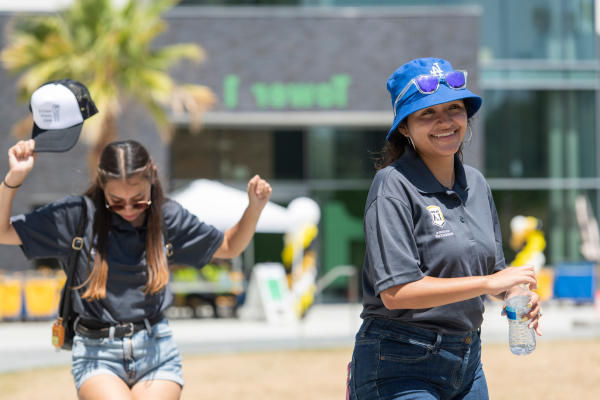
top-left (347, 58), bottom-right (541, 400)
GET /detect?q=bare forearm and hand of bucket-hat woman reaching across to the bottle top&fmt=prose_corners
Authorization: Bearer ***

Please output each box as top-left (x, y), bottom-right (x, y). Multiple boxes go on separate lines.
top-left (381, 265), bottom-right (536, 310)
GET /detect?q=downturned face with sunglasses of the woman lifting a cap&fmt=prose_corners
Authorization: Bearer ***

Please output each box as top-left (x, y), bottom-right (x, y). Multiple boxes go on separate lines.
top-left (104, 177), bottom-right (151, 226)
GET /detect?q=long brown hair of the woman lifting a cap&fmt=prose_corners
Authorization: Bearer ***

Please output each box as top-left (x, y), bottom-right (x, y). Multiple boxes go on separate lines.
top-left (78, 140), bottom-right (169, 301)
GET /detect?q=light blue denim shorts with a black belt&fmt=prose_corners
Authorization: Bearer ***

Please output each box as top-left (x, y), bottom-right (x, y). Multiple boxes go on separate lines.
top-left (71, 318), bottom-right (183, 390)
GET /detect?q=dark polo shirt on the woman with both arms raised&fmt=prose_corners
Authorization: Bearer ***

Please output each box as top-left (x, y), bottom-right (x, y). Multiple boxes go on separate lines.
top-left (11, 196), bottom-right (224, 324)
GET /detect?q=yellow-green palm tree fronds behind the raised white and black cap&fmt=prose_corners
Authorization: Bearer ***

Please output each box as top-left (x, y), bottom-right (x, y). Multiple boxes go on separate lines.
top-left (0, 0), bottom-right (216, 174)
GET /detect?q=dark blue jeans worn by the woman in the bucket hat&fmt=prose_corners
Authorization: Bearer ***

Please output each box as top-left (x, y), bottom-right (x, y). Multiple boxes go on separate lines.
top-left (348, 318), bottom-right (489, 400)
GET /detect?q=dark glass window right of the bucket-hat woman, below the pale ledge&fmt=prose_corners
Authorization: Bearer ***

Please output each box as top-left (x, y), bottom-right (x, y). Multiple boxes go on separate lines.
top-left (483, 90), bottom-right (596, 178)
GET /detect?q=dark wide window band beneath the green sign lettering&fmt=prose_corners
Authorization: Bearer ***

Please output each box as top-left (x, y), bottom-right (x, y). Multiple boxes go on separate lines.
top-left (171, 127), bottom-right (387, 180)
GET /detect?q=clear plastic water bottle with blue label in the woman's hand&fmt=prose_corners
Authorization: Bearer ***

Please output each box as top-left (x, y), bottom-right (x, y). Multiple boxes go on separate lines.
top-left (504, 284), bottom-right (535, 356)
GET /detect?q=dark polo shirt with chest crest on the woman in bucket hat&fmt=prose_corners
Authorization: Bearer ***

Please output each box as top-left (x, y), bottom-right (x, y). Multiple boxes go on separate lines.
top-left (361, 146), bottom-right (505, 334)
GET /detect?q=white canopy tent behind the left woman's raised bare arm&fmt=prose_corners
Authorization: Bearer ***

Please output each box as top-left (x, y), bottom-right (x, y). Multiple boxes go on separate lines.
top-left (170, 179), bottom-right (310, 233)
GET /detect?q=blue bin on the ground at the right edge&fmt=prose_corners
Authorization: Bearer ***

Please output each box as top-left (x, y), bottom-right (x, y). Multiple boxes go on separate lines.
top-left (554, 261), bottom-right (597, 303)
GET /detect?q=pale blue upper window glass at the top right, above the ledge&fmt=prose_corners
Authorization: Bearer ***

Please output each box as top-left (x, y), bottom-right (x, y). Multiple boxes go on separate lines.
top-left (318, 0), bottom-right (595, 60)
